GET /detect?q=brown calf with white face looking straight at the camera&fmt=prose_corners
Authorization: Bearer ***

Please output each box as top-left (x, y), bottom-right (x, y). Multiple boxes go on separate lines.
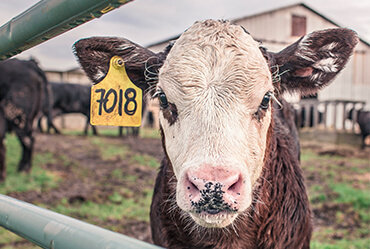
top-left (75, 20), bottom-right (358, 248)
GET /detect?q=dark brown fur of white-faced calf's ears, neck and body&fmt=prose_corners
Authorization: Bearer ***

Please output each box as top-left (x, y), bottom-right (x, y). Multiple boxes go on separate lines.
top-left (75, 21), bottom-right (358, 249)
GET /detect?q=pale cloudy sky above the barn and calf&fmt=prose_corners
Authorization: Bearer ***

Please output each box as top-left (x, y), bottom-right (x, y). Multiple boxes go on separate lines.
top-left (0, 0), bottom-right (370, 71)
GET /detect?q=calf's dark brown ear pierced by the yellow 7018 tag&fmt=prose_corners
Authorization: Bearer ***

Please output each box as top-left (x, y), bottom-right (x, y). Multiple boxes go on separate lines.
top-left (73, 37), bottom-right (169, 92)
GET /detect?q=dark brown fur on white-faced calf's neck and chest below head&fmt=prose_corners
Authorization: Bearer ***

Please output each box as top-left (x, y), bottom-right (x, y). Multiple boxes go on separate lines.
top-left (151, 99), bottom-right (312, 249)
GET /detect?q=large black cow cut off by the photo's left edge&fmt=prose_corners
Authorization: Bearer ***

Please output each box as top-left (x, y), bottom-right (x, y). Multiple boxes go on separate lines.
top-left (0, 59), bottom-right (47, 181)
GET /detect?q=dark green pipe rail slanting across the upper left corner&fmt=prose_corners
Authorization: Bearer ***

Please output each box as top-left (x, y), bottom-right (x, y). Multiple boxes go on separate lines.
top-left (0, 0), bottom-right (132, 60)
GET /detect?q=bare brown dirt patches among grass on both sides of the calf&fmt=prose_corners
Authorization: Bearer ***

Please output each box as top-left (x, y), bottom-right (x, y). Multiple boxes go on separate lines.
top-left (5, 133), bottom-right (370, 247)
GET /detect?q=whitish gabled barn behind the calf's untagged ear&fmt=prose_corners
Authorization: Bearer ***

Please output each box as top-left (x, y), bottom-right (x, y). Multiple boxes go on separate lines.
top-left (149, 3), bottom-right (370, 129)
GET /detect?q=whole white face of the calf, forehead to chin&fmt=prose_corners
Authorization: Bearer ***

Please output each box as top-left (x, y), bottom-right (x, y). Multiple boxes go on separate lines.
top-left (157, 21), bottom-right (273, 227)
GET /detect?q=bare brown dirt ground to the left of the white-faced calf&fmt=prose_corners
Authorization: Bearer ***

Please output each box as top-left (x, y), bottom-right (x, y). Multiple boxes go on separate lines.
top-left (9, 133), bottom-right (163, 245)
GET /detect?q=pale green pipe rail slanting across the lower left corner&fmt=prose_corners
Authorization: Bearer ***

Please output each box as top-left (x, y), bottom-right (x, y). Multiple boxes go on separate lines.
top-left (0, 194), bottom-right (161, 249)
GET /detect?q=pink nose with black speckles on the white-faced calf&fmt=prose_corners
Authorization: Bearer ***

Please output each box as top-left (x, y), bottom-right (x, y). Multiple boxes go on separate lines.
top-left (185, 166), bottom-right (244, 214)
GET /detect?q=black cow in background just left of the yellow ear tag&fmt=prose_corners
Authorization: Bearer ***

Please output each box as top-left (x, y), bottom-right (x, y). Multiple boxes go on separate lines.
top-left (38, 82), bottom-right (97, 135)
